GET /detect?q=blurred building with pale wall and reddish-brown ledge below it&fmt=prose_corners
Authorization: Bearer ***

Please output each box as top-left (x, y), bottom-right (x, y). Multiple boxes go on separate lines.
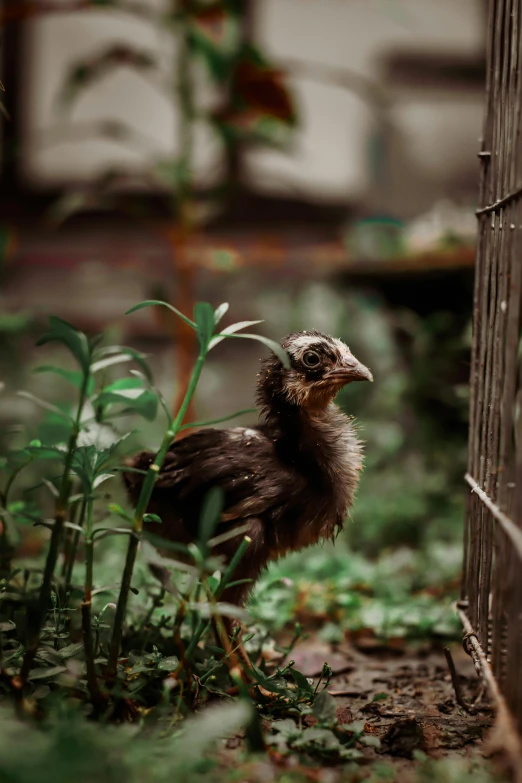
top-left (0, 0), bottom-right (486, 388)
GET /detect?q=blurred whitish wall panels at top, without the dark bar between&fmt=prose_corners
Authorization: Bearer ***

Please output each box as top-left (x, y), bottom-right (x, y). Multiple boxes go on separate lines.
top-left (24, 0), bottom-right (483, 211)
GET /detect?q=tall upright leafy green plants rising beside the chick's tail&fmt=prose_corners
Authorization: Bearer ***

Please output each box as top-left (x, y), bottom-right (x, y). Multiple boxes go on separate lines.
top-left (0, 302), bottom-right (288, 708)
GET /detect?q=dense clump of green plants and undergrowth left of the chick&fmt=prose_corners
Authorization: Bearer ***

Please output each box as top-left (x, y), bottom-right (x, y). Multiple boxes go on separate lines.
top-left (0, 303), bottom-right (360, 780)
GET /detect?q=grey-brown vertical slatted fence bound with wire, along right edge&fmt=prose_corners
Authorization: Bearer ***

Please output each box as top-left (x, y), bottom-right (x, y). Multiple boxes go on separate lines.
top-left (462, 0), bottom-right (522, 748)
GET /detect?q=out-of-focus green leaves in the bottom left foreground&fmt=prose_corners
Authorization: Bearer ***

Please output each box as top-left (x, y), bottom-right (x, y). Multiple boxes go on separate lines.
top-left (0, 700), bottom-right (251, 783)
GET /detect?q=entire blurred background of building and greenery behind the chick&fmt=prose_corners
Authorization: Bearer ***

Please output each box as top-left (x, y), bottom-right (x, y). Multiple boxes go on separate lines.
top-left (0, 0), bottom-right (487, 596)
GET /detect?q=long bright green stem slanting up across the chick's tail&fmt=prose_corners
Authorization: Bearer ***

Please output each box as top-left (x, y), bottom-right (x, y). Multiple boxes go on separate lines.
top-left (107, 351), bottom-right (206, 682)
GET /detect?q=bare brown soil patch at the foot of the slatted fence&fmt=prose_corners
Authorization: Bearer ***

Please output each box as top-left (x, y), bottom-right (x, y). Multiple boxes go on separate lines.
top-left (329, 645), bottom-right (493, 760)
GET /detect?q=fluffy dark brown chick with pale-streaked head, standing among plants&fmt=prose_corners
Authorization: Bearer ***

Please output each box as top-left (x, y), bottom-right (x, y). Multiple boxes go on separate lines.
top-left (124, 331), bottom-right (373, 605)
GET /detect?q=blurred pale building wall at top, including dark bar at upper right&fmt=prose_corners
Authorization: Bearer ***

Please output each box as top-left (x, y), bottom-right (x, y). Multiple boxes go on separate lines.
top-left (4, 0), bottom-right (485, 217)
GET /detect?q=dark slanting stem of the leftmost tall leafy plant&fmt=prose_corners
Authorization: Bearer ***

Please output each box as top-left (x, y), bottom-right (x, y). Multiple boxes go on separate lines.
top-left (20, 370), bottom-right (90, 687)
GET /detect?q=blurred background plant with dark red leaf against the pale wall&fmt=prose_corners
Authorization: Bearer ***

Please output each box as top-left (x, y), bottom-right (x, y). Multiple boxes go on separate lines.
top-left (39, 0), bottom-right (297, 227)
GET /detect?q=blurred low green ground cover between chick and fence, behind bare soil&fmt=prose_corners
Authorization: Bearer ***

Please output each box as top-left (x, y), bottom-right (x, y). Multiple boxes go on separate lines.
top-left (251, 539), bottom-right (461, 642)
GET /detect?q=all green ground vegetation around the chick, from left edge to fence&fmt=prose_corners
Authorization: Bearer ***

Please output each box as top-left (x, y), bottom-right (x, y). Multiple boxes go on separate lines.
top-left (0, 302), bottom-right (492, 783)
